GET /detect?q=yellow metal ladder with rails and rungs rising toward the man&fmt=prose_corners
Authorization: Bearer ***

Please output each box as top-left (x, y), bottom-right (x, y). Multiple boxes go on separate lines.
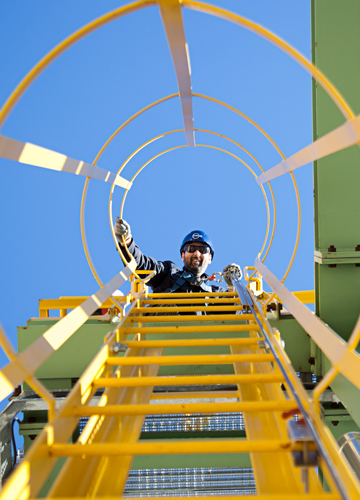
top-left (1, 270), bottom-right (359, 500)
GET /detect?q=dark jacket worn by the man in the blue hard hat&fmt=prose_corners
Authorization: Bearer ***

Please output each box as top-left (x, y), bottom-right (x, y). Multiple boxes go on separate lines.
top-left (119, 240), bottom-right (226, 293)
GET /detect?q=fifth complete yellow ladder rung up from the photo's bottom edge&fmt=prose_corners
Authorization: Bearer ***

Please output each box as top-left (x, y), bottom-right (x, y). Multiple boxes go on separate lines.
top-left (123, 337), bottom-right (264, 348)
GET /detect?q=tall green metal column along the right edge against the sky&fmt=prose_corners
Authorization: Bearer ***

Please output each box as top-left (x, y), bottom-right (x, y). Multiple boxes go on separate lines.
top-left (312, 0), bottom-right (360, 435)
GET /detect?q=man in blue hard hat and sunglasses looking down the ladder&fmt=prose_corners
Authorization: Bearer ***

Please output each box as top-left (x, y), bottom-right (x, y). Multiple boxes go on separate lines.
top-left (114, 217), bottom-right (241, 293)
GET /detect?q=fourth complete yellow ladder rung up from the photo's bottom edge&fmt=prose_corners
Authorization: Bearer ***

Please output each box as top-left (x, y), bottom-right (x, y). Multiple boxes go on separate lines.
top-left (106, 354), bottom-right (274, 366)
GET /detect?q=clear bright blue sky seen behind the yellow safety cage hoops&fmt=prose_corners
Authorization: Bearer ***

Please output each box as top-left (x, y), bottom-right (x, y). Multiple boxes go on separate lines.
top-left (0, 0), bottom-right (314, 372)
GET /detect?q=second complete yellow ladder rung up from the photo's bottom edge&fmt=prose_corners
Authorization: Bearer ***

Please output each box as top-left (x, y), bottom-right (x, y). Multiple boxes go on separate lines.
top-left (71, 401), bottom-right (297, 417)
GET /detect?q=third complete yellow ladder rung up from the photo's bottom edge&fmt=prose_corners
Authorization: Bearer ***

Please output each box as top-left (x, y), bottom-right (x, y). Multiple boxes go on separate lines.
top-left (93, 373), bottom-right (284, 388)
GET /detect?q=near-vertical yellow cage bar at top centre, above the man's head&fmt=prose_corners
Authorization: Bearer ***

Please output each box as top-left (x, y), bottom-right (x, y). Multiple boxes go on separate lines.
top-left (157, 0), bottom-right (195, 147)
